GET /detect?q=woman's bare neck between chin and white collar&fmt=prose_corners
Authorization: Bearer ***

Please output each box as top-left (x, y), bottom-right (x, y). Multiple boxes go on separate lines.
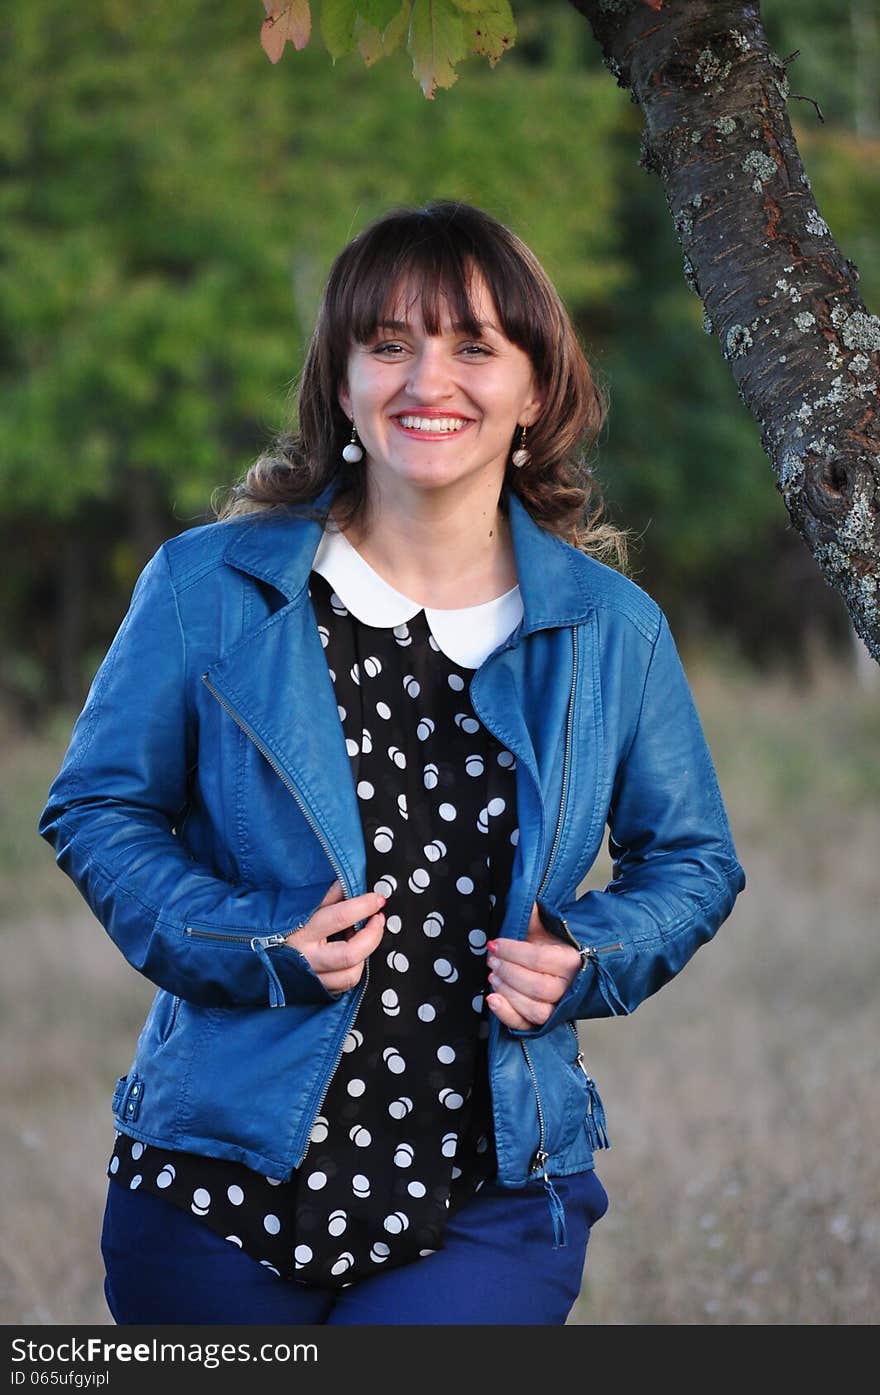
top-left (336, 480), bottom-right (517, 608)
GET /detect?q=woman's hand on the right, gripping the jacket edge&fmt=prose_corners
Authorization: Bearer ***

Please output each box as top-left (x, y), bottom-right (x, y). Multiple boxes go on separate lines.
top-left (485, 903), bottom-right (580, 1031)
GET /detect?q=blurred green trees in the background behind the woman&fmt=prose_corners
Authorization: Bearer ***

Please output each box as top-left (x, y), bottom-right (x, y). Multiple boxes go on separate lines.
top-left (0, 0), bottom-right (880, 704)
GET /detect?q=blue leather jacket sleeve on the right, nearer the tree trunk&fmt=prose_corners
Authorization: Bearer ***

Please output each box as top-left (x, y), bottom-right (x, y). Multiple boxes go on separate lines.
top-left (519, 618), bottom-right (745, 1036)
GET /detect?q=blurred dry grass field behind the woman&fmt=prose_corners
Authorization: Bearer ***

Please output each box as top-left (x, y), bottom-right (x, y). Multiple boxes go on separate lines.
top-left (0, 664), bottom-right (880, 1325)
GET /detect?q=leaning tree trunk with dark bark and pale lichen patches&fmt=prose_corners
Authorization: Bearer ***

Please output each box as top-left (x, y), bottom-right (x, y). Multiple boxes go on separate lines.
top-left (570, 0), bottom-right (880, 661)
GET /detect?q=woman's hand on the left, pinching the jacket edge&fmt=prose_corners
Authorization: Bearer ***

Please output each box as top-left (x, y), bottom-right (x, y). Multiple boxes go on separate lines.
top-left (286, 882), bottom-right (385, 993)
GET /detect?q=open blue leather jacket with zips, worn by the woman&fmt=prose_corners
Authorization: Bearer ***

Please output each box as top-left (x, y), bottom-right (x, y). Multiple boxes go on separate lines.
top-left (40, 474), bottom-right (745, 1190)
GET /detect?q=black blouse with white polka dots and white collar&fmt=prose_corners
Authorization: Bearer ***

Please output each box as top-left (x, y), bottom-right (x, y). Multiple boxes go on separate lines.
top-left (109, 533), bottom-right (522, 1288)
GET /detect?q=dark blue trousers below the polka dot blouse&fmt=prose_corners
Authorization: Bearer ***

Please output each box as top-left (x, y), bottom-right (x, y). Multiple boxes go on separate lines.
top-left (102, 1172), bottom-right (608, 1327)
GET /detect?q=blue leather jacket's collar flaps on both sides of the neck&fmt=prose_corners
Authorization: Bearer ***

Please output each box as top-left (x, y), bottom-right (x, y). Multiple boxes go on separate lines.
top-left (223, 478), bottom-right (594, 635)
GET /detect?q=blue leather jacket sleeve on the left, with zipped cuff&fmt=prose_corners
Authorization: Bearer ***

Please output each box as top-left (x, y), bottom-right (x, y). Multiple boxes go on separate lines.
top-left (39, 538), bottom-right (344, 1007)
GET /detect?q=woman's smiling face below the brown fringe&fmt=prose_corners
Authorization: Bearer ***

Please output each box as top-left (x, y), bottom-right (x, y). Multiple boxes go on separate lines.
top-left (339, 273), bottom-right (541, 498)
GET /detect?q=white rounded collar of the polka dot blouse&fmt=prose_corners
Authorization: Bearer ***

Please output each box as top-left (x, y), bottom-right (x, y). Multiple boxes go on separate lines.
top-left (312, 527), bottom-right (523, 668)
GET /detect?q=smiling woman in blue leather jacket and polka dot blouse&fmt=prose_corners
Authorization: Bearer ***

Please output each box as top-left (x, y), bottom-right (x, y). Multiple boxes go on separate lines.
top-left (40, 202), bottom-right (743, 1325)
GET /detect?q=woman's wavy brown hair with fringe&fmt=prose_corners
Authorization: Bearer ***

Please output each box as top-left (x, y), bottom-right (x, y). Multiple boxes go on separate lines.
top-left (219, 201), bottom-right (626, 568)
